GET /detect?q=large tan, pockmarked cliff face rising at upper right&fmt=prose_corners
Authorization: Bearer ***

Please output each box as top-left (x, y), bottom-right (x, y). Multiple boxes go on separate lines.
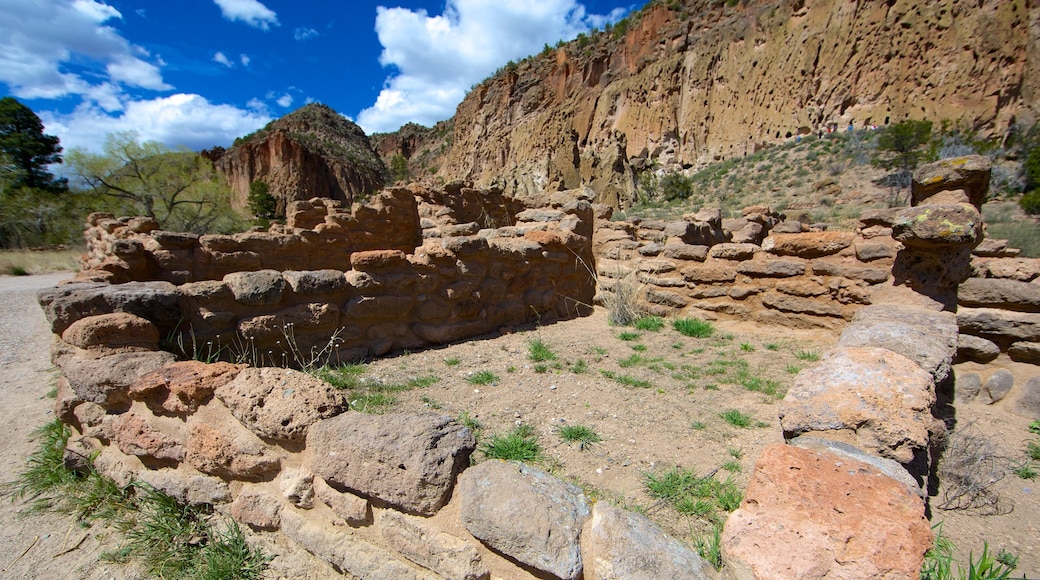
top-left (391, 0), bottom-right (1040, 207)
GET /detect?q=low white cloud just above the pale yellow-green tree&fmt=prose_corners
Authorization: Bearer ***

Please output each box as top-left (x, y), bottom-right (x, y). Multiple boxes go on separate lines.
top-left (40, 94), bottom-right (270, 152)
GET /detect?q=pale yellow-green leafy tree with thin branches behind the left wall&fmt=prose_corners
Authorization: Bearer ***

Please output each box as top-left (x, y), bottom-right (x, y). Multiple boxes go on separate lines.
top-left (68, 131), bottom-right (242, 234)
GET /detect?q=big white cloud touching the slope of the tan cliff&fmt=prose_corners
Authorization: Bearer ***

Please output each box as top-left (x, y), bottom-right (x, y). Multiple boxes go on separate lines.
top-left (358, 0), bottom-right (625, 133)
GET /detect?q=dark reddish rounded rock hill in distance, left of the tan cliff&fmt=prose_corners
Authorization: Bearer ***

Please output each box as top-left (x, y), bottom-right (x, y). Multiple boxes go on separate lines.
top-left (214, 104), bottom-right (387, 215)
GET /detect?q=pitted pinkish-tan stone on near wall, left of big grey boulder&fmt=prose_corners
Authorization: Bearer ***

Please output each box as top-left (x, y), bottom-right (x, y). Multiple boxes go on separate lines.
top-left (215, 368), bottom-right (347, 441)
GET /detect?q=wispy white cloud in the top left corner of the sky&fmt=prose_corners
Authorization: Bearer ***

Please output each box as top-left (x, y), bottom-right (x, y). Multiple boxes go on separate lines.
top-left (0, 0), bottom-right (173, 104)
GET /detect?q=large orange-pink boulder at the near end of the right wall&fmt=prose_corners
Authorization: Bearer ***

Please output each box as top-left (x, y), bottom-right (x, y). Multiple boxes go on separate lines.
top-left (723, 444), bottom-right (933, 580)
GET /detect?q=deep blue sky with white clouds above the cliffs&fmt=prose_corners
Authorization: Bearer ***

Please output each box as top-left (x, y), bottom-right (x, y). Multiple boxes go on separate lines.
top-left (0, 0), bottom-right (624, 151)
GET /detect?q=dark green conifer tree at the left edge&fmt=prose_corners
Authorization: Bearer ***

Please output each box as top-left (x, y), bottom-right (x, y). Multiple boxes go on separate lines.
top-left (0, 97), bottom-right (69, 192)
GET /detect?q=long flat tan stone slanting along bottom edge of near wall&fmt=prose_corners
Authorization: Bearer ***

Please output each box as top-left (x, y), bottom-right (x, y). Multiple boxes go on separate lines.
top-left (281, 508), bottom-right (439, 580)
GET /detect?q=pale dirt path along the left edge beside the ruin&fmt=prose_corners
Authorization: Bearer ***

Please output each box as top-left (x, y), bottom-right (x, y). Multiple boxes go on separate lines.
top-left (0, 272), bottom-right (137, 579)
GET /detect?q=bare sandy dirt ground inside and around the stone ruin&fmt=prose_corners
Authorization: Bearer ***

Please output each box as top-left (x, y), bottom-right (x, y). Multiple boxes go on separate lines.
top-left (0, 274), bottom-right (1040, 579)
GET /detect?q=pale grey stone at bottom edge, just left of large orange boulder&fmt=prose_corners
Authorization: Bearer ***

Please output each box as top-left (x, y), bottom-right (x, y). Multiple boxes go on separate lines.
top-left (581, 501), bottom-right (712, 580)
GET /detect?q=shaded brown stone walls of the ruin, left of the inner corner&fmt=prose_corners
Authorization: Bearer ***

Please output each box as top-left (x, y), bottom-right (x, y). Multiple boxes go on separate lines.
top-left (67, 184), bottom-right (594, 366)
